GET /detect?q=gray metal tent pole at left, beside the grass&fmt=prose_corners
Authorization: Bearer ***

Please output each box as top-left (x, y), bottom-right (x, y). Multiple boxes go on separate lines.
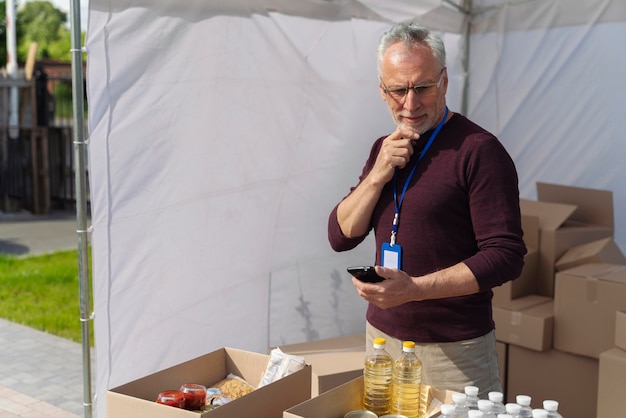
top-left (70, 0), bottom-right (93, 418)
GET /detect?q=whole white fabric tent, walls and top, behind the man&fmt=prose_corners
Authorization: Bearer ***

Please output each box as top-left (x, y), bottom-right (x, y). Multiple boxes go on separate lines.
top-left (86, 0), bottom-right (626, 416)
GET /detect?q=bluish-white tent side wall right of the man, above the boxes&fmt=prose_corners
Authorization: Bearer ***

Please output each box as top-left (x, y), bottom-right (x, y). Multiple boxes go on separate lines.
top-left (469, 1), bottom-right (626, 225)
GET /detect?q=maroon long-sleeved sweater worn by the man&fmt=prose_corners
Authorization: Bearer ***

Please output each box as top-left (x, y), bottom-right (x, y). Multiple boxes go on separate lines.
top-left (328, 114), bottom-right (526, 342)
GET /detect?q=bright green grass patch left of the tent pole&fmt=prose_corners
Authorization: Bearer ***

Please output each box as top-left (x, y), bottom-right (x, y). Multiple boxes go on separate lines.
top-left (0, 250), bottom-right (93, 345)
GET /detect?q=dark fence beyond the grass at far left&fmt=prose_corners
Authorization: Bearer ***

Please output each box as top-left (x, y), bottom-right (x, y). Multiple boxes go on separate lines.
top-left (0, 69), bottom-right (88, 214)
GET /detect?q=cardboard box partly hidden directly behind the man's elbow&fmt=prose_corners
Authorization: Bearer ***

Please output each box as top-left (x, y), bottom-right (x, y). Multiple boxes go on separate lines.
top-left (492, 215), bottom-right (539, 305)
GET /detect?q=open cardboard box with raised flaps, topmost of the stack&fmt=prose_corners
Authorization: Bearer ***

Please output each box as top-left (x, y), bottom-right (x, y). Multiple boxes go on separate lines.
top-left (520, 183), bottom-right (614, 297)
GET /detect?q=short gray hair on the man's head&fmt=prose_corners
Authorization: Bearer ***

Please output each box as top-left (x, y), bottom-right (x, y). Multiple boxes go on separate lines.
top-left (377, 22), bottom-right (446, 74)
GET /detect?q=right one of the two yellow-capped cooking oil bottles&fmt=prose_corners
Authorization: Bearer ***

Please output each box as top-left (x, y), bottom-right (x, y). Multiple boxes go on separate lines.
top-left (391, 341), bottom-right (422, 418)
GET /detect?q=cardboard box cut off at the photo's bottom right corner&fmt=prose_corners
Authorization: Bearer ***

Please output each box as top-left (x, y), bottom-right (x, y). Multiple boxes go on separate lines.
top-left (596, 348), bottom-right (626, 418)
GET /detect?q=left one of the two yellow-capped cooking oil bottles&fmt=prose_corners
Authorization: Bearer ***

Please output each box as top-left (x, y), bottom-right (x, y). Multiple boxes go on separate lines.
top-left (363, 338), bottom-right (393, 416)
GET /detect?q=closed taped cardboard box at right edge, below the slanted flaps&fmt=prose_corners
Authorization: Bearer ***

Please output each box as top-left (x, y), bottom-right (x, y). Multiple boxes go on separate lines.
top-left (553, 264), bottom-right (626, 358)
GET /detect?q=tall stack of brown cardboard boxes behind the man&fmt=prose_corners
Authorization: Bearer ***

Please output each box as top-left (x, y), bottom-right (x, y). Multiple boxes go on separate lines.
top-left (493, 183), bottom-right (626, 418)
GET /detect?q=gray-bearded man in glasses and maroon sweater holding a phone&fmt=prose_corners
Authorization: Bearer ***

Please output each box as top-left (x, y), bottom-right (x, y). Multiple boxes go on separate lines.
top-left (328, 24), bottom-right (526, 397)
